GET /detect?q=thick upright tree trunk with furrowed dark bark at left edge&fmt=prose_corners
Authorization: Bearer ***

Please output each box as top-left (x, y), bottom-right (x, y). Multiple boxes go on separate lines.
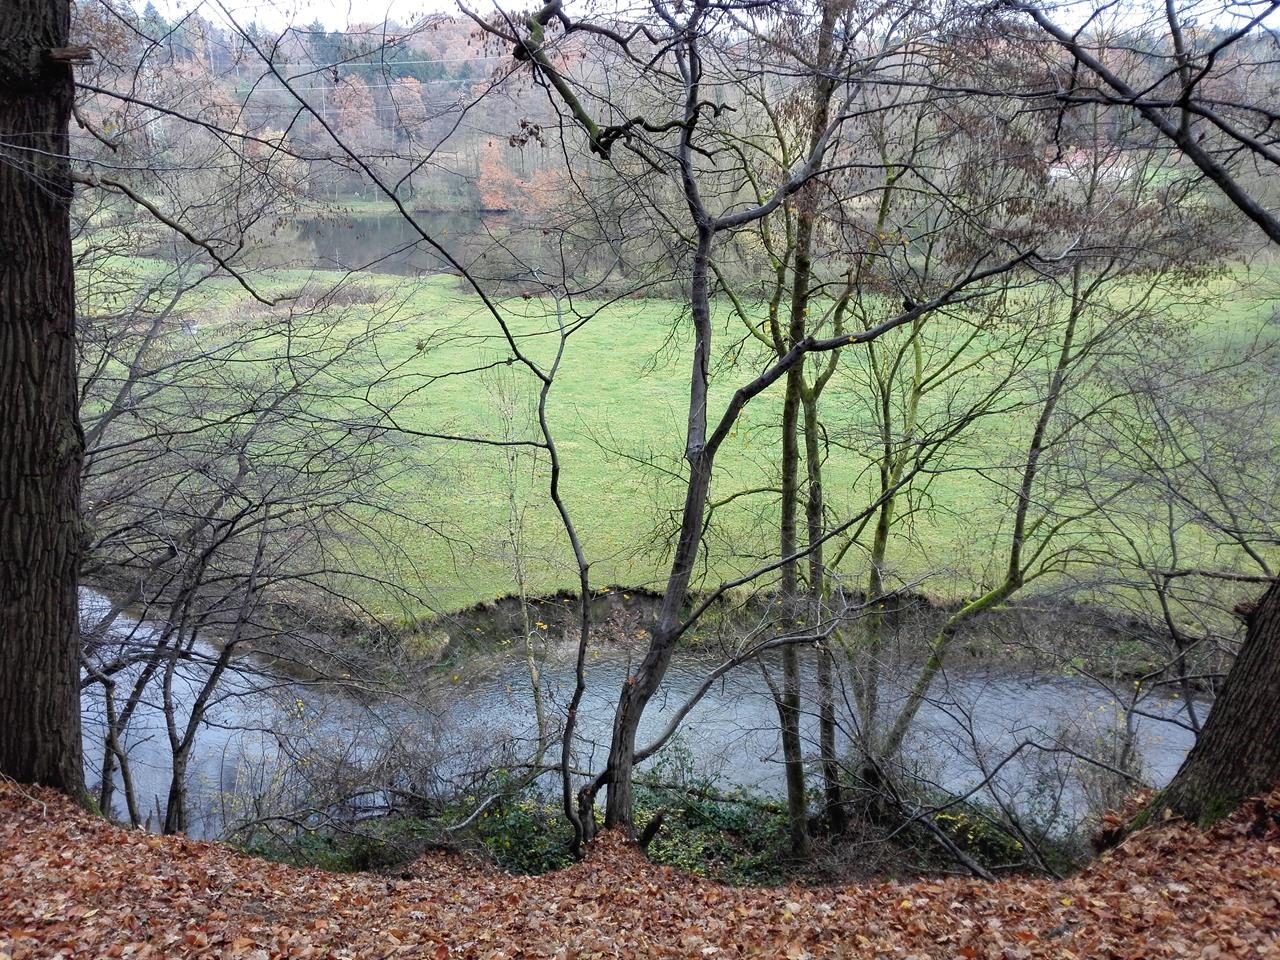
top-left (0, 0), bottom-right (84, 799)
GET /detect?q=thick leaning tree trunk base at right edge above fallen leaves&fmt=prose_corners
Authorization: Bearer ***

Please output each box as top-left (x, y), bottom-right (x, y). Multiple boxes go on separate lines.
top-left (1157, 581), bottom-right (1280, 824)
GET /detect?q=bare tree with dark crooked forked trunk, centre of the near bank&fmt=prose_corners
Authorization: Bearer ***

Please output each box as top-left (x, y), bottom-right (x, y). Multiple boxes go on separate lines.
top-left (476, 3), bottom-right (1049, 827)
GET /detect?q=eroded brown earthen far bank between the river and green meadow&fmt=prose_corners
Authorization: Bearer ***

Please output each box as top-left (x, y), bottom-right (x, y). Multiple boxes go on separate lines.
top-left (299, 585), bottom-right (1212, 694)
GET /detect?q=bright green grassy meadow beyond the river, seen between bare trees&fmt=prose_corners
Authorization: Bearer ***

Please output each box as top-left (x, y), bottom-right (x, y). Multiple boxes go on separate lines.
top-left (85, 252), bottom-right (1280, 616)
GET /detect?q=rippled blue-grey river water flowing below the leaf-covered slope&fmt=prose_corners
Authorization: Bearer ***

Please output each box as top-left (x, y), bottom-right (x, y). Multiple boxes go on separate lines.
top-left (82, 590), bottom-right (1192, 836)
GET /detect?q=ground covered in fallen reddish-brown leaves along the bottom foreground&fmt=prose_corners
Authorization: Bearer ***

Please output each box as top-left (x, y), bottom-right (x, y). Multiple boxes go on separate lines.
top-left (0, 783), bottom-right (1280, 960)
